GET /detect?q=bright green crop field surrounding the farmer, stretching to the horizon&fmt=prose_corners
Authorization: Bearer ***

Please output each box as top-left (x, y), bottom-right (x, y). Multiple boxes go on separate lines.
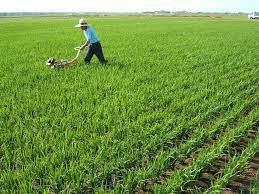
top-left (0, 16), bottom-right (259, 194)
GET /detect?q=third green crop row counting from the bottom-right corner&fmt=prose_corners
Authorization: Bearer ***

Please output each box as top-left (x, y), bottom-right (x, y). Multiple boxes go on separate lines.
top-left (115, 92), bottom-right (258, 192)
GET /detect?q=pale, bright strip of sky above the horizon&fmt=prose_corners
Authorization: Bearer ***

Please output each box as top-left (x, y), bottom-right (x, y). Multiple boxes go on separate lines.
top-left (0, 0), bottom-right (259, 12)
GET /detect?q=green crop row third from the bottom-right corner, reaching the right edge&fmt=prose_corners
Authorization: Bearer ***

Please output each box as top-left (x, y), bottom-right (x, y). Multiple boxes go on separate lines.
top-left (129, 91), bottom-right (258, 193)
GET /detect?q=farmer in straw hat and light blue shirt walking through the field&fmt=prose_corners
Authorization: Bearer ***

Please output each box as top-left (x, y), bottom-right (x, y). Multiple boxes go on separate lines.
top-left (75, 19), bottom-right (108, 64)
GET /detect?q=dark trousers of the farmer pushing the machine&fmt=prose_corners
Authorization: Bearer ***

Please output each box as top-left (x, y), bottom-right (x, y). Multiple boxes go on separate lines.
top-left (85, 42), bottom-right (107, 64)
